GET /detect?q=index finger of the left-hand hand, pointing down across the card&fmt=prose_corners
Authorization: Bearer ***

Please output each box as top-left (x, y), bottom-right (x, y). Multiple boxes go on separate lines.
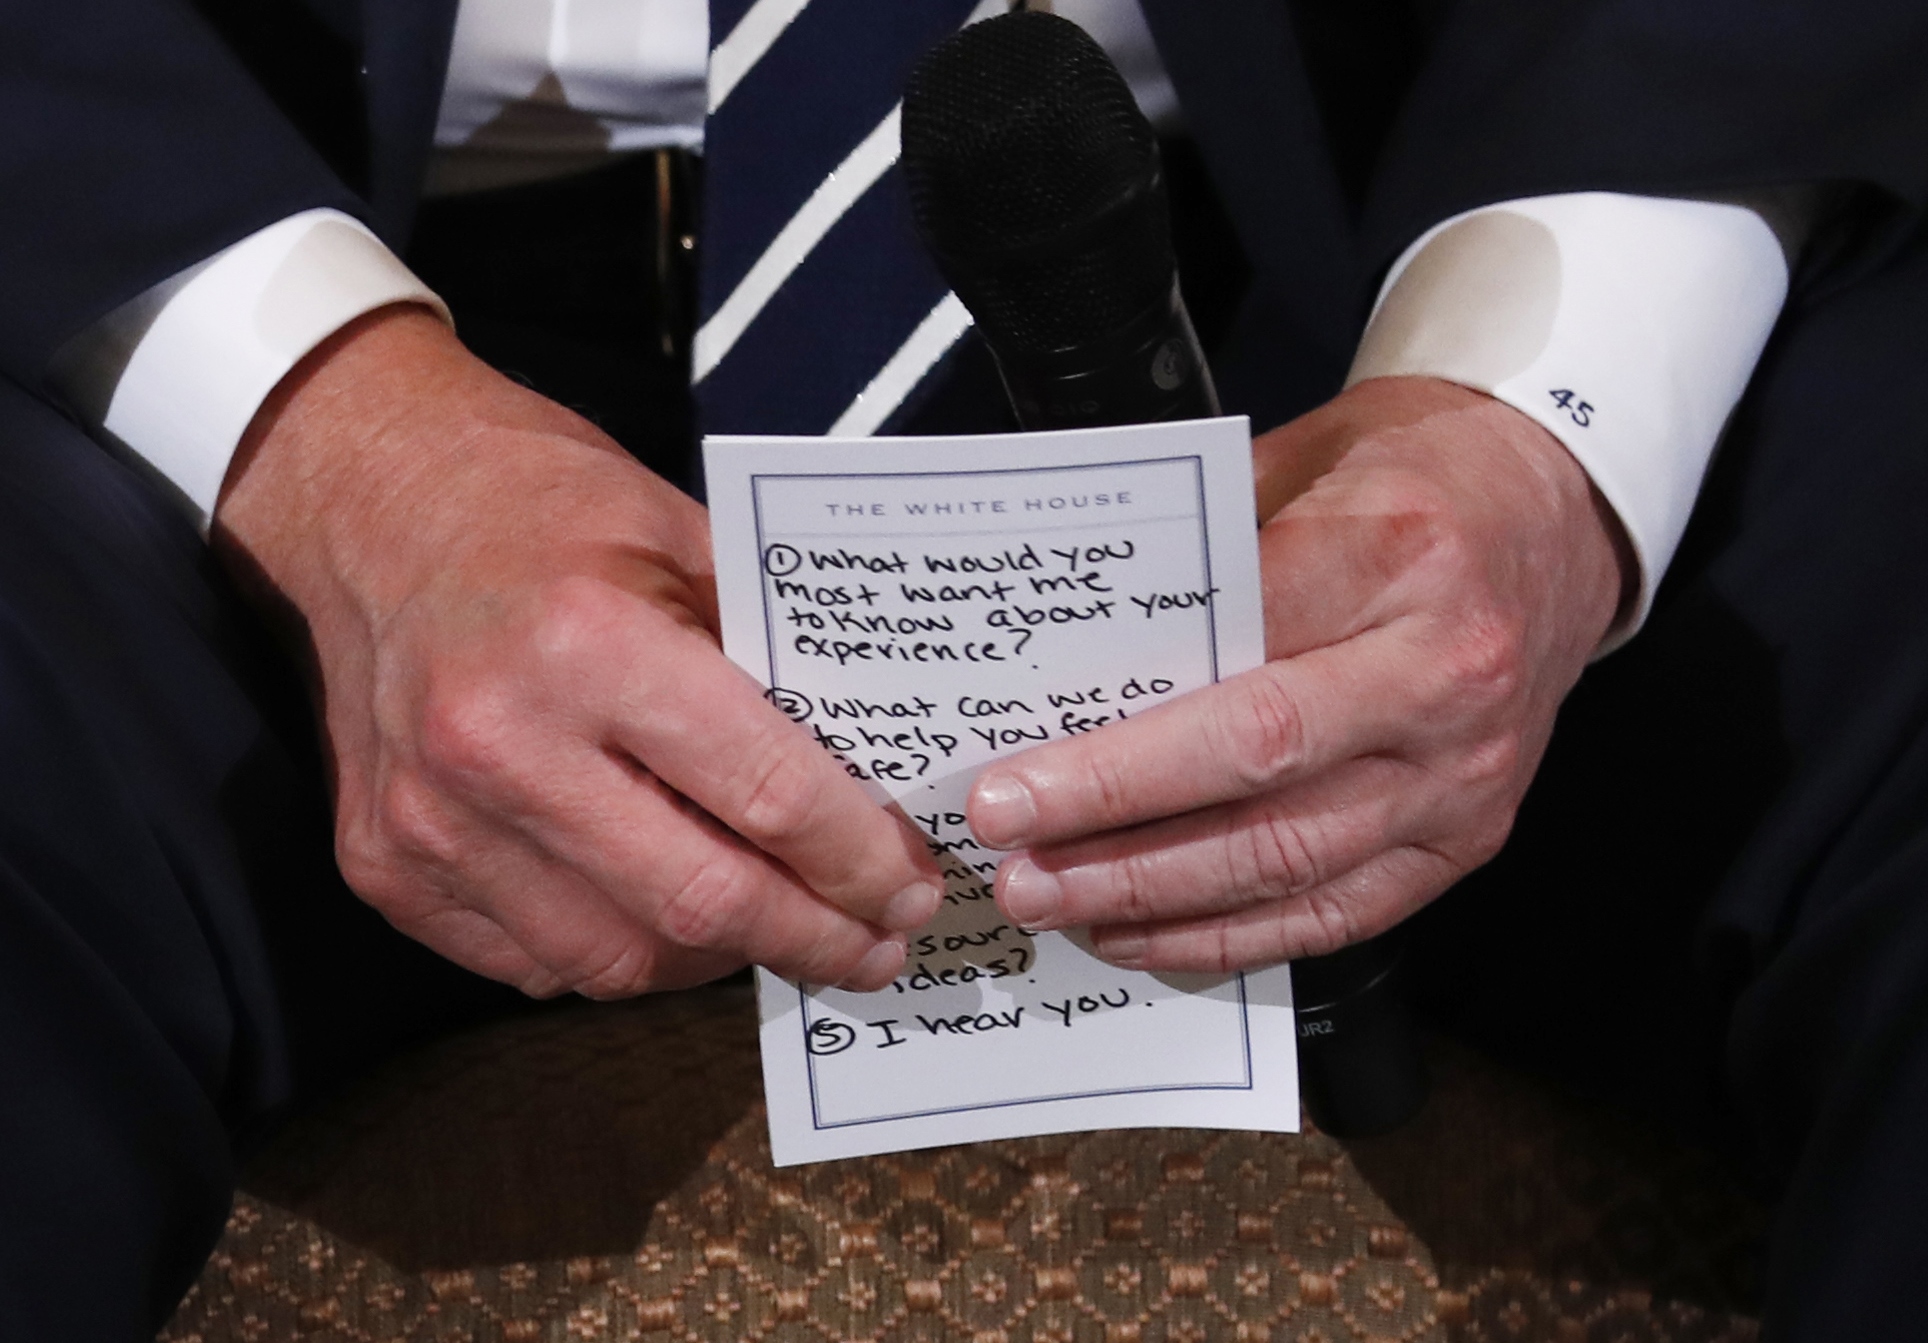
top-left (615, 619), bottom-right (943, 931)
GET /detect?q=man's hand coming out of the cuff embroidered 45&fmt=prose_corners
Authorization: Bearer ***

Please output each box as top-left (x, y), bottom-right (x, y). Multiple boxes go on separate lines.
top-left (970, 378), bottom-right (1633, 971)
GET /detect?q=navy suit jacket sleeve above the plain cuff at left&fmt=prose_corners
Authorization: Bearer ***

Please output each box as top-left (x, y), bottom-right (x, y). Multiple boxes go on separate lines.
top-left (0, 0), bottom-right (364, 395)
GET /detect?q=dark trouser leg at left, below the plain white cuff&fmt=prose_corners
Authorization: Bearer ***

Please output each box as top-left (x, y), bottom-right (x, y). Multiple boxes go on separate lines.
top-left (0, 382), bottom-right (516, 1343)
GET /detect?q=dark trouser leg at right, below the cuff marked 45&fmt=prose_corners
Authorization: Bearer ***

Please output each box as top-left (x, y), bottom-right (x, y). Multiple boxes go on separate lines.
top-left (1417, 240), bottom-right (1928, 1339)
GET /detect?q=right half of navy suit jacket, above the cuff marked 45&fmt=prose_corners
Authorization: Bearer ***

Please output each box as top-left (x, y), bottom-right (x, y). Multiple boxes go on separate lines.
top-left (1143, 0), bottom-right (1928, 428)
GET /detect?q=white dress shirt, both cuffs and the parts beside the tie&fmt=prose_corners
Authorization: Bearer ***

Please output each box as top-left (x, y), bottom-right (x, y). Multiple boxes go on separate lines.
top-left (45, 0), bottom-right (1787, 644)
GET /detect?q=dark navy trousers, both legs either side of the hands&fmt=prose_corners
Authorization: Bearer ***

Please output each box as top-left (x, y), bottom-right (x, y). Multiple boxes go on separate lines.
top-left (0, 159), bottom-right (1928, 1343)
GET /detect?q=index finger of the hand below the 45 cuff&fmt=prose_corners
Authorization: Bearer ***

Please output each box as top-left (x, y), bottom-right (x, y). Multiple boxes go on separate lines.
top-left (966, 626), bottom-right (1425, 848)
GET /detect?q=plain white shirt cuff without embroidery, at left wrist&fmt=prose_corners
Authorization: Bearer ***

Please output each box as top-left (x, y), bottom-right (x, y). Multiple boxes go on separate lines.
top-left (54, 210), bottom-right (449, 528)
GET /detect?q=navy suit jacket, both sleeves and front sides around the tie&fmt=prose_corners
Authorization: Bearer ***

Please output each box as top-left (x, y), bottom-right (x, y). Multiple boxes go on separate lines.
top-left (0, 0), bottom-right (1928, 439)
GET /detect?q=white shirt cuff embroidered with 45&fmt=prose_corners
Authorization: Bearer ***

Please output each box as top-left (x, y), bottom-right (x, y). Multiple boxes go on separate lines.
top-left (1346, 193), bottom-right (1787, 653)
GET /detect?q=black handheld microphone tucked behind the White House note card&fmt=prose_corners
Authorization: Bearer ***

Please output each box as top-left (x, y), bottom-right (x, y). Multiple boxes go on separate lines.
top-left (902, 12), bottom-right (1427, 1137)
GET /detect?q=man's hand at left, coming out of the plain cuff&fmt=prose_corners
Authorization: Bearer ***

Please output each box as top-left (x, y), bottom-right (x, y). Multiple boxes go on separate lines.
top-left (216, 308), bottom-right (943, 998)
